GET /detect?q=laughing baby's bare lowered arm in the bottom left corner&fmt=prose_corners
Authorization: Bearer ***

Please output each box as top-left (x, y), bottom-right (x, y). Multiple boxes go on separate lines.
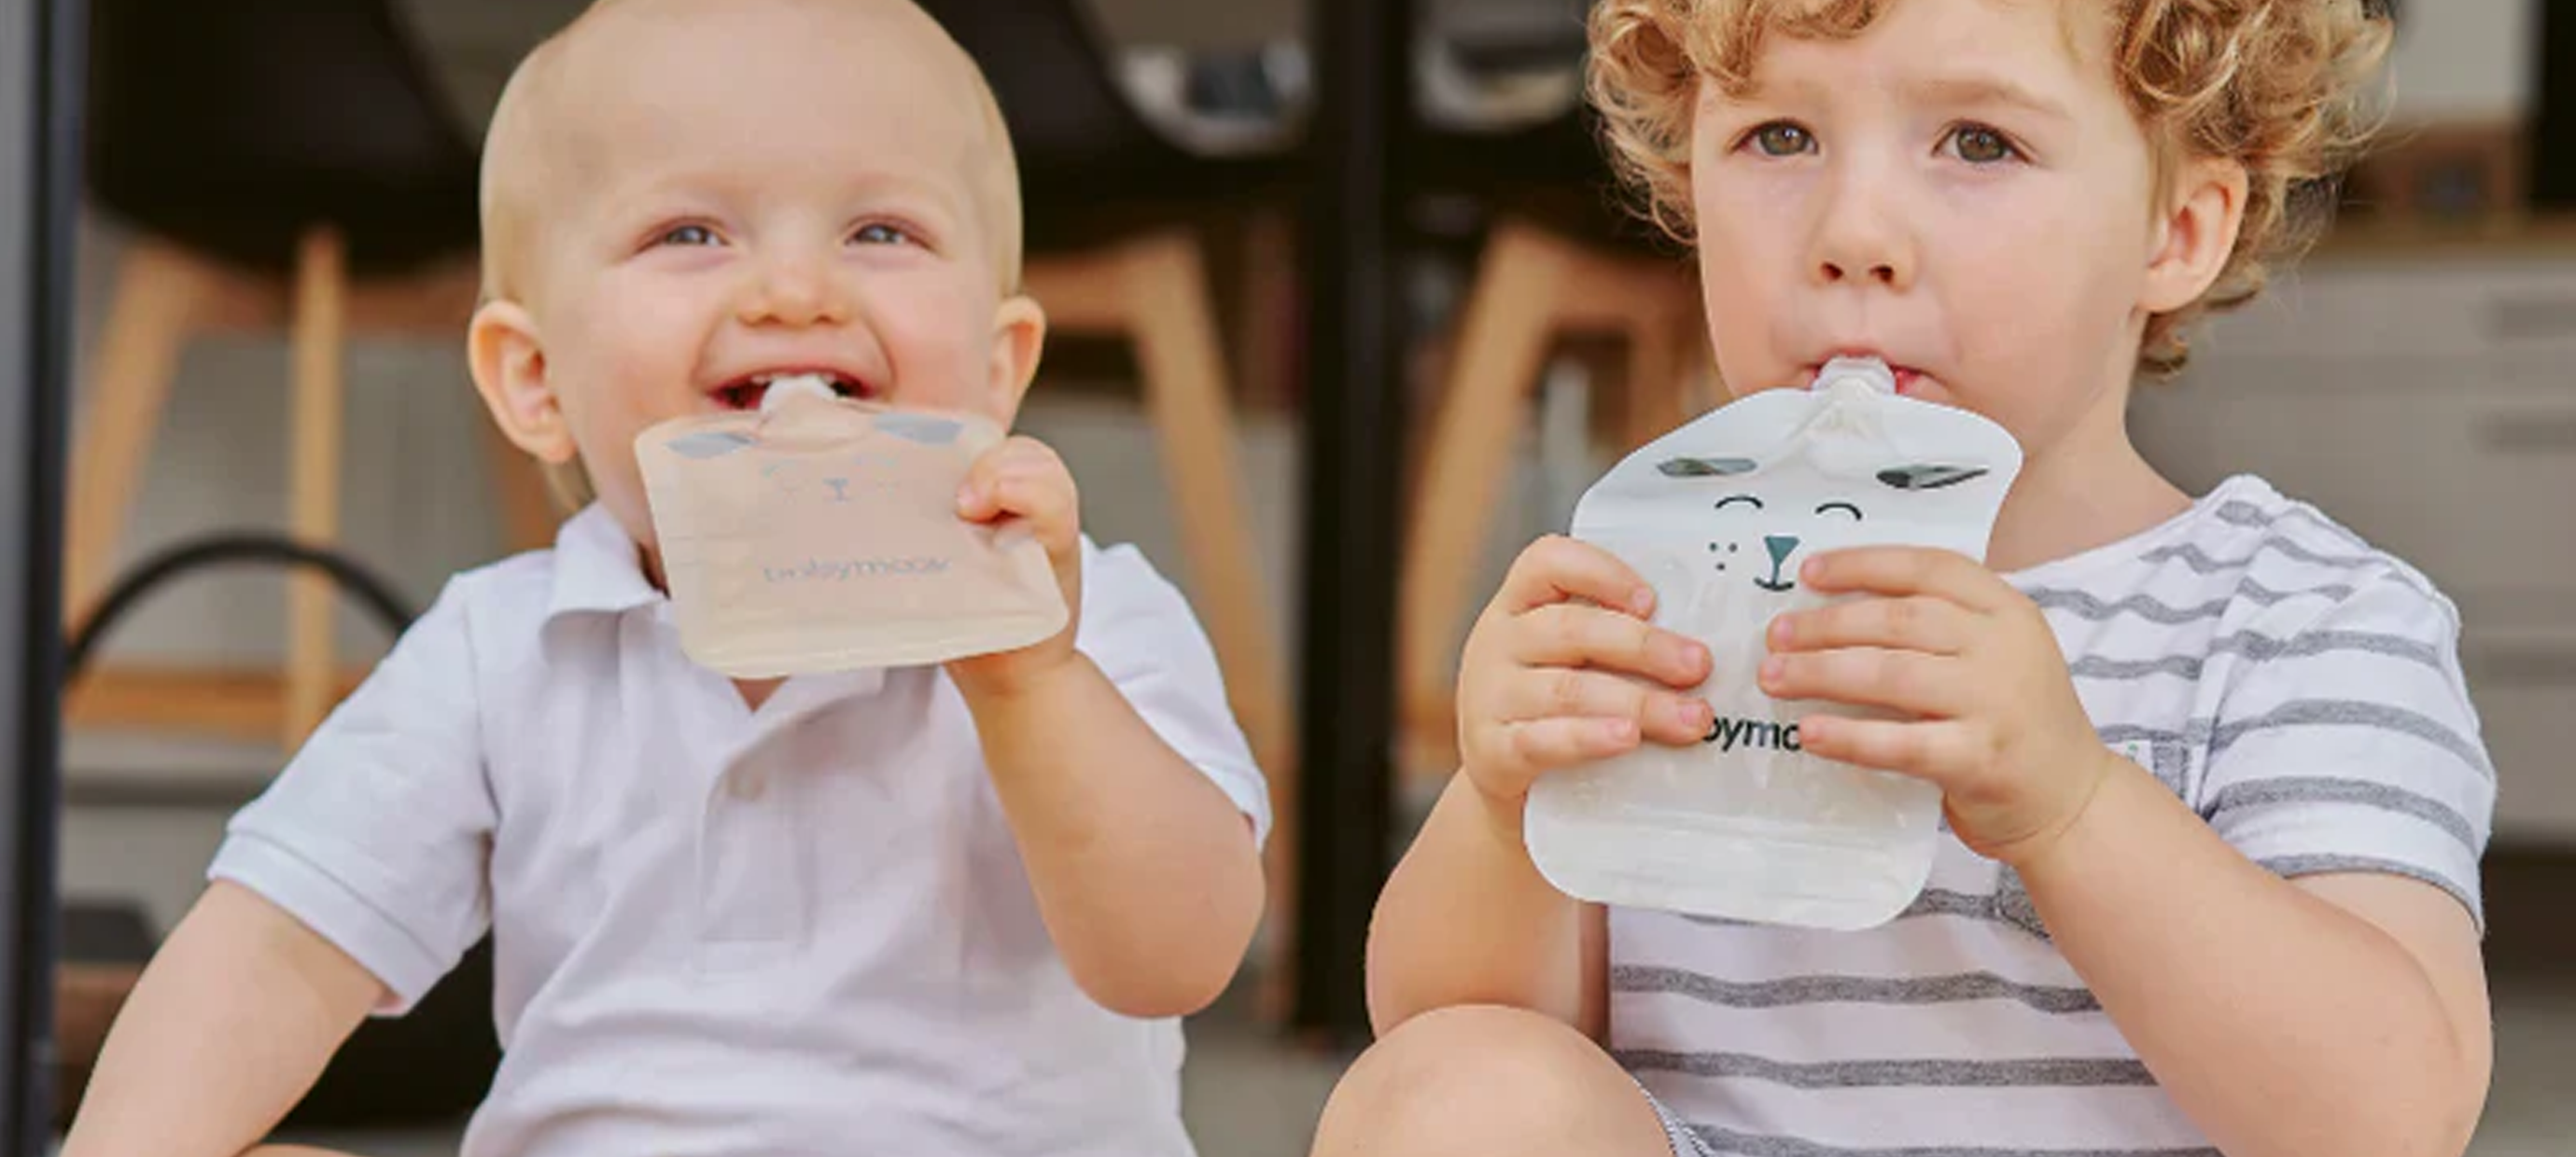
top-left (62, 881), bottom-right (384, 1157)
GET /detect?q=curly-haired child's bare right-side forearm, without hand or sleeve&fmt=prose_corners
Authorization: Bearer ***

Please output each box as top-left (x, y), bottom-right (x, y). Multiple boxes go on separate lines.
top-left (2020, 767), bottom-right (2491, 1157)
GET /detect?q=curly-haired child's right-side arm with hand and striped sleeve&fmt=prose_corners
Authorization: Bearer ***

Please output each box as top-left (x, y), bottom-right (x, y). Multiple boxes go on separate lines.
top-left (1759, 549), bottom-right (2494, 1157)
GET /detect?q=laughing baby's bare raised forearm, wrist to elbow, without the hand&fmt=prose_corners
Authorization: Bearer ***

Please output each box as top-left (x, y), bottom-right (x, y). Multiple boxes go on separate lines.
top-left (969, 654), bottom-right (1262, 1018)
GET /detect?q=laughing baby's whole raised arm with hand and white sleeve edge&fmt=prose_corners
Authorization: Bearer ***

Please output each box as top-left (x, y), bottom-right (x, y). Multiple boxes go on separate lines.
top-left (948, 438), bottom-right (1262, 1018)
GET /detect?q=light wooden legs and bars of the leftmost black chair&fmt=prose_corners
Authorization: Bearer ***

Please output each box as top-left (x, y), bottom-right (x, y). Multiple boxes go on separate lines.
top-left (64, 227), bottom-right (553, 752)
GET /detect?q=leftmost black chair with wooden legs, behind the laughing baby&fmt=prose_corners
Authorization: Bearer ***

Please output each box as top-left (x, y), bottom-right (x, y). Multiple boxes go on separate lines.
top-left (64, 0), bottom-right (564, 747)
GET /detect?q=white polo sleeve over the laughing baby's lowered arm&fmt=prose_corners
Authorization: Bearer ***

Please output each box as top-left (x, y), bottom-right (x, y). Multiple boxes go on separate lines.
top-left (206, 582), bottom-right (495, 1012)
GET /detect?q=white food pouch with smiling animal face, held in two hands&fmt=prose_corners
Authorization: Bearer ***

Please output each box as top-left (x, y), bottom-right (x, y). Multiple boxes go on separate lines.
top-left (1525, 361), bottom-right (2023, 927)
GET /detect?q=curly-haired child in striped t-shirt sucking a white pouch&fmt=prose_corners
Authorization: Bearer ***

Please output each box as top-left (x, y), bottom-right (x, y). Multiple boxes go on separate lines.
top-left (1316, 0), bottom-right (2496, 1157)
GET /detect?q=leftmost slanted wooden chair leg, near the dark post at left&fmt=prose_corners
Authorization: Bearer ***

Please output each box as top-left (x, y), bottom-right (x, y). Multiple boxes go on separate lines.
top-left (62, 237), bottom-right (219, 626)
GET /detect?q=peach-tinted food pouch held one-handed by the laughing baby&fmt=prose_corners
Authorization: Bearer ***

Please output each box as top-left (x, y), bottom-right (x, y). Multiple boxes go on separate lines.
top-left (637, 376), bottom-right (1069, 677)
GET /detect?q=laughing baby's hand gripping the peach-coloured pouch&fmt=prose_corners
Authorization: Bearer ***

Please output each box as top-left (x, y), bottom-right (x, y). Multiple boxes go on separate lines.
top-left (948, 438), bottom-right (1082, 693)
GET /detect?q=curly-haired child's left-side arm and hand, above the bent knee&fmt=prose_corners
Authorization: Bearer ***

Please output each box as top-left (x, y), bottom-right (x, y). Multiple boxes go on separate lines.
top-left (1368, 538), bottom-right (1708, 1036)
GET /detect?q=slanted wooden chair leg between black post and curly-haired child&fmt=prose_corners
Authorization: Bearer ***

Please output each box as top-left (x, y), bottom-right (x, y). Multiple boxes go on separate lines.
top-left (1396, 224), bottom-right (1569, 762)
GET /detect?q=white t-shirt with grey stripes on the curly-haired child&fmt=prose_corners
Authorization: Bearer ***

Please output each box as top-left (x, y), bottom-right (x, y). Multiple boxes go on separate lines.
top-left (1610, 477), bottom-right (2496, 1157)
